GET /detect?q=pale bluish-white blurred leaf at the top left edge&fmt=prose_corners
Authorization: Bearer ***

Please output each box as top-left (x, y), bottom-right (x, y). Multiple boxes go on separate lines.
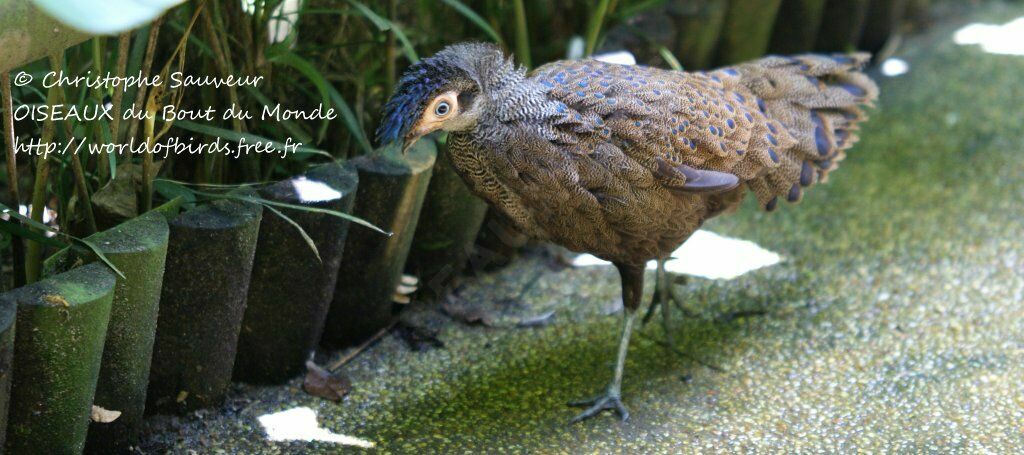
top-left (32, 0), bottom-right (183, 35)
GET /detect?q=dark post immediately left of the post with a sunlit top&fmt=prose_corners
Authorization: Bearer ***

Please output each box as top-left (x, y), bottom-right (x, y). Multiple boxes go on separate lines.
top-left (146, 200), bottom-right (261, 413)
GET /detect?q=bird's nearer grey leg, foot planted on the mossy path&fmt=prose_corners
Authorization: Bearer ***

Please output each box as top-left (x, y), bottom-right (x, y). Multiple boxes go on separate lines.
top-left (569, 264), bottom-right (643, 423)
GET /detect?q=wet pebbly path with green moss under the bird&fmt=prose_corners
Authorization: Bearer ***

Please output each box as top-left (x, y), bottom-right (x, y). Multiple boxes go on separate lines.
top-left (147, 4), bottom-right (1024, 453)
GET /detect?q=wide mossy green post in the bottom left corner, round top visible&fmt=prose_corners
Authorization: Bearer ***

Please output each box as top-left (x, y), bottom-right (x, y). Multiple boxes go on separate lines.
top-left (0, 262), bottom-right (117, 453)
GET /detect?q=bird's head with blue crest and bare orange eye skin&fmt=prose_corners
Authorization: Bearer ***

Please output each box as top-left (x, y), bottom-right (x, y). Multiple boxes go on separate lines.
top-left (377, 43), bottom-right (505, 152)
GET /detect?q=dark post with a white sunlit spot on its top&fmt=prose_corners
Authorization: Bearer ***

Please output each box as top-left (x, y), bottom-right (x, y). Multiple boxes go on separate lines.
top-left (234, 163), bottom-right (360, 383)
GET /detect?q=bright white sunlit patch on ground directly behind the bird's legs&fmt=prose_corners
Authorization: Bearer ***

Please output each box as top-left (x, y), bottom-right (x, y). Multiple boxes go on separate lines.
top-left (572, 230), bottom-right (782, 280)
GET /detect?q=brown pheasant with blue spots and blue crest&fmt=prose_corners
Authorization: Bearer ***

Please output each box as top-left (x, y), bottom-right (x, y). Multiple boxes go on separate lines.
top-left (376, 43), bottom-right (879, 422)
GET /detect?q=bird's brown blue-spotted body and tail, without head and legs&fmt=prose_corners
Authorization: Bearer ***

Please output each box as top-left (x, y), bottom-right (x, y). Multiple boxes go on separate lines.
top-left (452, 54), bottom-right (877, 263)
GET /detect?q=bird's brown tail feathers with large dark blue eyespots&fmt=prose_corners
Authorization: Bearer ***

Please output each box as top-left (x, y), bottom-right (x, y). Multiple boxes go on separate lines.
top-left (736, 53), bottom-right (879, 210)
